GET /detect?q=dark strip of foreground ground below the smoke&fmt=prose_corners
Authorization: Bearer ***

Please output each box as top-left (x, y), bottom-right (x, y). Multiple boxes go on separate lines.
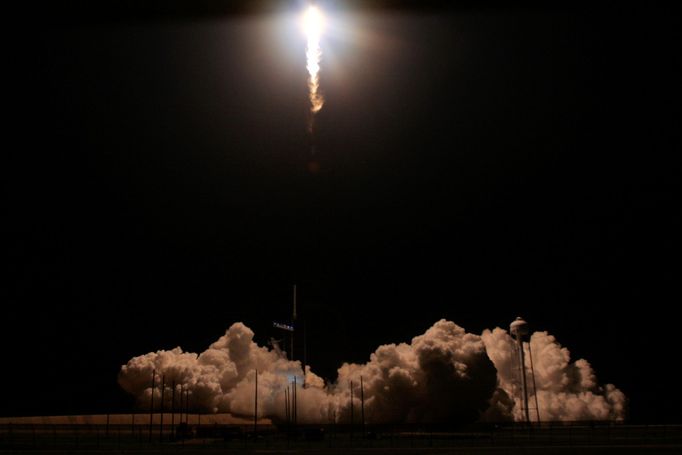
top-left (0, 419), bottom-right (682, 455)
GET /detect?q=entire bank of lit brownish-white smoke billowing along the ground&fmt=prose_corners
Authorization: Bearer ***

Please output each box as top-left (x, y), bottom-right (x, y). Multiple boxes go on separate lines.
top-left (119, 320), bottom-right (626, 423)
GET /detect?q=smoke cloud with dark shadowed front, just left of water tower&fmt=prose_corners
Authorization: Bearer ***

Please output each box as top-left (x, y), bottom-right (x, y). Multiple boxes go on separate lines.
top-left (337, 320), bottom-right (496, 422)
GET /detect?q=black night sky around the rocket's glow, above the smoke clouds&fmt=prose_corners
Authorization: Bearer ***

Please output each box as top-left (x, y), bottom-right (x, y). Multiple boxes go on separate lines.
top-left (0, 1), bottom-right (682, 421)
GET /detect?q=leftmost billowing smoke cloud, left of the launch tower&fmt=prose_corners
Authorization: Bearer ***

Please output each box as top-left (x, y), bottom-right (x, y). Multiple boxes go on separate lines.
top-left (119, 322), bottom-right (306, 416)
